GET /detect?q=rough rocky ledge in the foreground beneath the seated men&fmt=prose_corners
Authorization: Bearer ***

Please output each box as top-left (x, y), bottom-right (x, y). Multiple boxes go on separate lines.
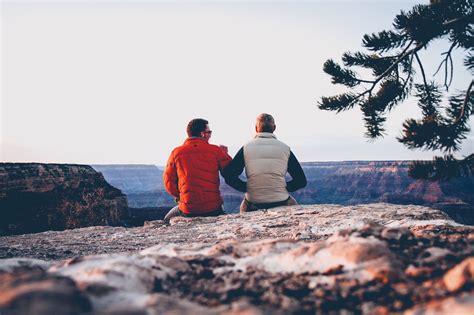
top-left (0, 204), bottom-right (474, 315)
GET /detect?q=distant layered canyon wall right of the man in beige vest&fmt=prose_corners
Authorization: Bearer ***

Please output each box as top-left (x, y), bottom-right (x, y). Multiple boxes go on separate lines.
top-left (295, 161), bottom-right (474, 206)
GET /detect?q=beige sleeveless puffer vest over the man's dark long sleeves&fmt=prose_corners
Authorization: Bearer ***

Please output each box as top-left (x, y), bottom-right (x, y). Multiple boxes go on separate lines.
top-left (244, 132), bottom-right (290, 203)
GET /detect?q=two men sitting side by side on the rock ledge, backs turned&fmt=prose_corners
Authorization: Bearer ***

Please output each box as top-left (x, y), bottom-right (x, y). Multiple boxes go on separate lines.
top-left (163, 114), bottom-right (306, 222)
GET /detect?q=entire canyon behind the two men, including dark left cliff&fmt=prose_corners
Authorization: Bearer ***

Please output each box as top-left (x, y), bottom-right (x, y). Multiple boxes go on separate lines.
top-left (0, 161), bottom-right (474, 235)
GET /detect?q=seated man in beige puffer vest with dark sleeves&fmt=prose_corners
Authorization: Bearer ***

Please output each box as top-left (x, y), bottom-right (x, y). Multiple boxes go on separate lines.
top-left (223, 114), bottom-right (306, 213)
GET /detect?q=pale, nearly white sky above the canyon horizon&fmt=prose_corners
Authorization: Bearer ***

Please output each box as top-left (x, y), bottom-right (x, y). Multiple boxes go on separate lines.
top-left (0, 0), bottom-right (474, 165)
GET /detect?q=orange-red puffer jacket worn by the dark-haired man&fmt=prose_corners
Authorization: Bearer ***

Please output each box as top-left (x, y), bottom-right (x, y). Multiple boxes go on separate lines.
top-left (163, 138), bottom-right (232, 214)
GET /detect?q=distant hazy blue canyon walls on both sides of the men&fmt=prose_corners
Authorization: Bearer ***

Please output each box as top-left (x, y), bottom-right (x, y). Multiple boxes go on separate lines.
top-left (94, 161), bottom-right (474, 216)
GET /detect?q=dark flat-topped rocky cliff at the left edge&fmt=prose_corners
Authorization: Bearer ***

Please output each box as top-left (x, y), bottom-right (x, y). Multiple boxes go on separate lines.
top-left (0, 163), bottom-right (128, 235)
